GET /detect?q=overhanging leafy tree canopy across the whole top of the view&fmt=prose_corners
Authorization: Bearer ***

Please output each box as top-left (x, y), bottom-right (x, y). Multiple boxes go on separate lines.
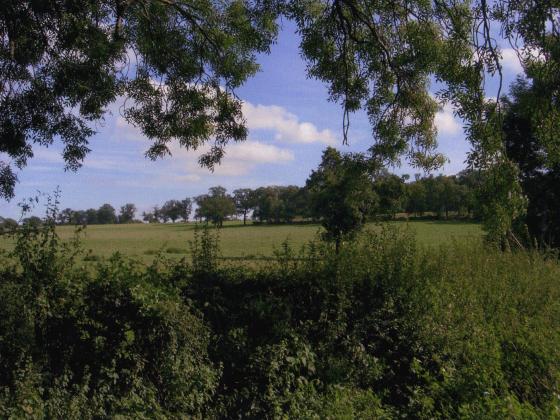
top-left (0, 0), bottom-right (560, 205)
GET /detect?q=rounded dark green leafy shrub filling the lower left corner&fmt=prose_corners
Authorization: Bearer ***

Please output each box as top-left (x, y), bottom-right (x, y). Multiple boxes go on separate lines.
top-left (0, 217), bottom-right (219, 418)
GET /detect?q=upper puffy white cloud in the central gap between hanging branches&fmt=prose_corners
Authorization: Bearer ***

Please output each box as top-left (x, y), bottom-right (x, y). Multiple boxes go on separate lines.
top-left (243, 102), bottom-right (336, 144)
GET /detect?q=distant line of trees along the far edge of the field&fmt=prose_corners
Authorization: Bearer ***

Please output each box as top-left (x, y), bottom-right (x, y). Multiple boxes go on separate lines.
top-left (0, 167), bottom-right (482, 227)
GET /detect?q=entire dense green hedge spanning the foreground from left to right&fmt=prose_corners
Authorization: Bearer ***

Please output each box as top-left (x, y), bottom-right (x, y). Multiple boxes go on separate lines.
top-left (0, 221), bottom-right (560, 419)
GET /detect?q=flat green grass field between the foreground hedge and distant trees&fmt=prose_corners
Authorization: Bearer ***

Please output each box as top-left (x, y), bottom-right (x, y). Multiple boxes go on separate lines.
top-left (0, 221), bottom-right (482, 262)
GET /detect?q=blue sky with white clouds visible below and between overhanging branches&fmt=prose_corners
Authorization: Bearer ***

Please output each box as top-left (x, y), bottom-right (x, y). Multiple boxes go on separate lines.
top-left (0, 21), bottom-right (522, 219)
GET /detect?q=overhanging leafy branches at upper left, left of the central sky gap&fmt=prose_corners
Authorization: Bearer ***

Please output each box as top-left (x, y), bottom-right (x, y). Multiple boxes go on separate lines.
top-left (0, 0), bottom-right (276, 198)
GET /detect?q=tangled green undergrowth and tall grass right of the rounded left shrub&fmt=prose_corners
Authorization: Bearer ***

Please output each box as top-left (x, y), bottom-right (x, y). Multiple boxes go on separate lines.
top-left (184, 228), bottom-right (560, 418)
